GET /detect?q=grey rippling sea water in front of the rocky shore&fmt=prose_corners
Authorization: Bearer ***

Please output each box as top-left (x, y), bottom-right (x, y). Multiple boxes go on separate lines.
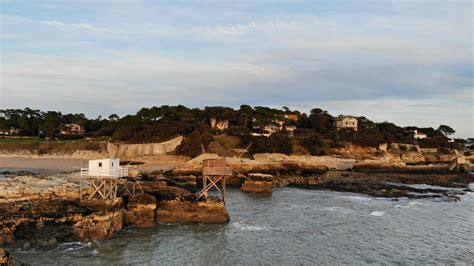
top-left (7, 188), bottom-right (474, 265)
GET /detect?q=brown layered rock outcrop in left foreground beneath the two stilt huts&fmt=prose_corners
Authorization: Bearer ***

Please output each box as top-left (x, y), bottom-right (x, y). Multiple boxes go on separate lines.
top-left (0, 172), bottom-right (229, 249)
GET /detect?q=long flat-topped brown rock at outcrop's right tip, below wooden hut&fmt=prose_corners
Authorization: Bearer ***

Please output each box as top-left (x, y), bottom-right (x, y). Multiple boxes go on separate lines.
top-left (157, 197), bottom-right (229, 223)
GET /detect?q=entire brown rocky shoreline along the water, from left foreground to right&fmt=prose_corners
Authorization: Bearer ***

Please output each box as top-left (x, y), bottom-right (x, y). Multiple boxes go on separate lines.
top-left (0, 156), bottom-right (474, 258)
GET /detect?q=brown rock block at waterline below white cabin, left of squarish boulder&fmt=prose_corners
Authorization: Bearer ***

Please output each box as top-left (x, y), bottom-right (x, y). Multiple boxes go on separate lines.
top-left (73, 209), bottom-right (123, 242)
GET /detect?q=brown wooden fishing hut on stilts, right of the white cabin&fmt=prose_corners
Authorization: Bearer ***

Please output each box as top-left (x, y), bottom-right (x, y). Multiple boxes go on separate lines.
top-left (197, 159), bottom-right (233, 204)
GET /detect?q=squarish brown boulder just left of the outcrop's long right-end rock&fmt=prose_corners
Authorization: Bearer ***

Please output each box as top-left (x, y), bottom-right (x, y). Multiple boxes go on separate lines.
top-left (124, 194), bottom-right (156, 228)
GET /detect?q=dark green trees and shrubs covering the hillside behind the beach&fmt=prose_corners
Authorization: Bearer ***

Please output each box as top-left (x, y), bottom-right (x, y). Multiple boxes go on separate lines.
top-left (0, 105), bottom-right (459, 156)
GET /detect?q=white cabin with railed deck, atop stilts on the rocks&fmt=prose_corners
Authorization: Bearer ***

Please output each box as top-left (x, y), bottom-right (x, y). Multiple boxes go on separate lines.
top-left (81, 159), bottom-right (128, 178)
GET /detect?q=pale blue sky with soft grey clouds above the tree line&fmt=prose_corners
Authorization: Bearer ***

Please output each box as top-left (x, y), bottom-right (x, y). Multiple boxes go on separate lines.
top-left (0, 0), bottom-right (474, 137)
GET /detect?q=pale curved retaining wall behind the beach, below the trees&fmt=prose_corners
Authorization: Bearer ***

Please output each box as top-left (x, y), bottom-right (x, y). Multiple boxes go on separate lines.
top-left (107, 136), bottom-right (183, 158)
